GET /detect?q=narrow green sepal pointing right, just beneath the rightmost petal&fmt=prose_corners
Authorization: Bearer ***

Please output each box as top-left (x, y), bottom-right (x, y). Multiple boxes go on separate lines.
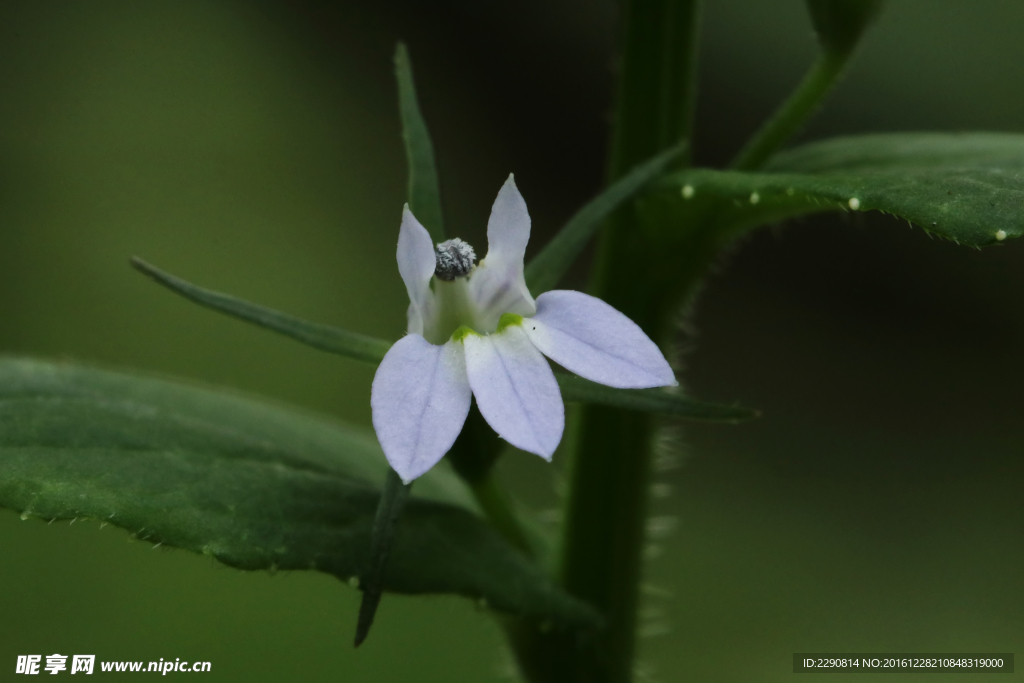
top-left (555, 373), bottom-right (759, 422)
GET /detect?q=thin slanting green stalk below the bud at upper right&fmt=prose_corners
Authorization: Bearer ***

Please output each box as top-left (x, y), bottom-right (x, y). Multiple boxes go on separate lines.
top-left (730, 49), bottom-right (853, 171)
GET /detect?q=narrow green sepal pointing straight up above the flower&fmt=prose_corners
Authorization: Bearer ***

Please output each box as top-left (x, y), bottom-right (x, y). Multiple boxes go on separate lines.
top-left (394, 43), bottom-right (444, 244)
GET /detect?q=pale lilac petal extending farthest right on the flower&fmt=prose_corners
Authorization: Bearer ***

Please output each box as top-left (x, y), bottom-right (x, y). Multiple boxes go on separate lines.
top-left (522, 290), bottom-right (678, 389)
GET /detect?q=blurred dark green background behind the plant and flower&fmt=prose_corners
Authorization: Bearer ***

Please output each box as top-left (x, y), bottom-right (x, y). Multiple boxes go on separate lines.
top-left (0, 0), bottom-right (1024, 682)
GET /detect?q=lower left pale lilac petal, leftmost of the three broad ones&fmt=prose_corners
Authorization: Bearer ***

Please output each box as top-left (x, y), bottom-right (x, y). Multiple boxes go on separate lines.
top-left (370, 335), bottom-right (471, 483)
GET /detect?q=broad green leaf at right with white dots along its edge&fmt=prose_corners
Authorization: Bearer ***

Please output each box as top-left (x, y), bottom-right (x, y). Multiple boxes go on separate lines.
top-left (663, 133), bottom-right (1024, 247)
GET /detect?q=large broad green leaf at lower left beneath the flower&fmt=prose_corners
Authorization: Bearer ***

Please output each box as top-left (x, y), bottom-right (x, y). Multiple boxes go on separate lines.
top-left (0, 358), bottom-right (596, 625)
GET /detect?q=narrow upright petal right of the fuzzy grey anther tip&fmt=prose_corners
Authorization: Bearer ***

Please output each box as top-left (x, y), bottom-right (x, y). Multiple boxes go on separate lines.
top-left (470, 175), bottom-right (537, 332)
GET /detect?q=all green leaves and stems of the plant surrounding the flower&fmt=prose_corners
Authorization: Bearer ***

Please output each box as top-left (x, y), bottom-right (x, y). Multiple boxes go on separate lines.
top-left (8, 6), bottom-right (1024, 682)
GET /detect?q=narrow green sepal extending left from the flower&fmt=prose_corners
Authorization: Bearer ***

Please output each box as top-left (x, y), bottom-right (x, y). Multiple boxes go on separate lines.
top-left (131, 257), bottom-right (391, 365)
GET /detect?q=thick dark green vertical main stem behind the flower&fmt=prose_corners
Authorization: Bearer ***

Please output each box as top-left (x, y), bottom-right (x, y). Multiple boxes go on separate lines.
top-left (510, 5), bottom-right (699, 683)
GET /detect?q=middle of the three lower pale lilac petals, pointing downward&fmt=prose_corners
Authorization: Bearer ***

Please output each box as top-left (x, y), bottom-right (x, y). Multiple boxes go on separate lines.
top-left (463, 325), bottom-right (565, 460)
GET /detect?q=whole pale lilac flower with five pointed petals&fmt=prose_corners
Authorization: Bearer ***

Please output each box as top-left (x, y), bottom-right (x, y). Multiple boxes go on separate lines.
top-left (370, 175), bottom-right (677, 483)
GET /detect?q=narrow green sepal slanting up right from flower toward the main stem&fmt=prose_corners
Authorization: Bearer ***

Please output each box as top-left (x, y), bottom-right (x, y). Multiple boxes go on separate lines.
top-left (525, 143), bottom-right (687, 297)
